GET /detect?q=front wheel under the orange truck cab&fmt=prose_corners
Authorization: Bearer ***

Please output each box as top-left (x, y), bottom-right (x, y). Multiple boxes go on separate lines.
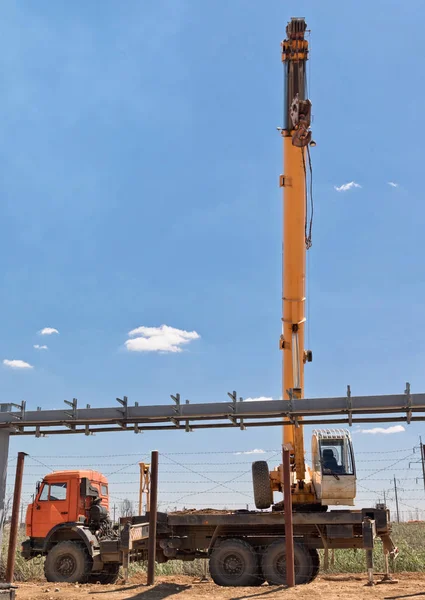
top-left (44, 541), bottom-right (91, 583)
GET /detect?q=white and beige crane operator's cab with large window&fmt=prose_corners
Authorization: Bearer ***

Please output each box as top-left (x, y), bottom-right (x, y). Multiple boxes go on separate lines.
top-left (312, 429), bottom-right (356, 506)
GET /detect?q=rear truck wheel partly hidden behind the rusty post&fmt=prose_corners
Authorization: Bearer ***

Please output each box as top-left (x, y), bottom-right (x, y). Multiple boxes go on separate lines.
top-left (262, 538), bottom-right (313, 585)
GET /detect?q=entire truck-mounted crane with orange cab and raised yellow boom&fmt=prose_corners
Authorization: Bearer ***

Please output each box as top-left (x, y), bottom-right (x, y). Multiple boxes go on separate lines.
top-left (22, 18), bottom-right (397, 586)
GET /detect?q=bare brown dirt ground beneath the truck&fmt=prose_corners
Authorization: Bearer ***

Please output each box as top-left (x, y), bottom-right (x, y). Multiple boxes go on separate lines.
top-left (10, 573), bottom-right (425, 600)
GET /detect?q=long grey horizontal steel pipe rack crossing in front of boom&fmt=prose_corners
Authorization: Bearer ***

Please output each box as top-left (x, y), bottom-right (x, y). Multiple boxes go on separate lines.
top-left (0, 386), bottom-right (425, 436)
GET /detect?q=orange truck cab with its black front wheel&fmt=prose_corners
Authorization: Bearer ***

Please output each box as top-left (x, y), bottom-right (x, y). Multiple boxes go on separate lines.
top-left (21, 470), bottom-right (121, 583)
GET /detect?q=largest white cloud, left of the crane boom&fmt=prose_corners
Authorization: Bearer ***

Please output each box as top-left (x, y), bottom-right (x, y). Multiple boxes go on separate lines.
top-left (125, 325), bottom-right (201, 352)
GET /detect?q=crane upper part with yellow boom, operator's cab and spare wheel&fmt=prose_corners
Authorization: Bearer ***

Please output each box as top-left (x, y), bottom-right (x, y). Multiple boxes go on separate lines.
top-left (252, 18), bottom-right (356, 511)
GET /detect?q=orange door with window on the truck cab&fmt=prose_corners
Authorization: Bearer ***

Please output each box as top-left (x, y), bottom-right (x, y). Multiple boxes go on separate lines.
top-left (32, 481), bottom-right (69, 538)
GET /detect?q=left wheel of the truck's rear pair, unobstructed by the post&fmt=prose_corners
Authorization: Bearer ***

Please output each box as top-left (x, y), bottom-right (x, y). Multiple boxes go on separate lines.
top-left (210, 539), bottom-right (261, 587)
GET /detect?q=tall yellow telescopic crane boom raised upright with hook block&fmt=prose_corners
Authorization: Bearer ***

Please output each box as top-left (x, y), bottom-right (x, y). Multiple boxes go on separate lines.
top-left (280, 18), bottom-right (314, 503)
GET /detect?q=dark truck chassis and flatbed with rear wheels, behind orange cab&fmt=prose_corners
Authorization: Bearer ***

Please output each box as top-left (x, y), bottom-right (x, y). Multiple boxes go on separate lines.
top-left (116, 508), bottom-right (397, 585)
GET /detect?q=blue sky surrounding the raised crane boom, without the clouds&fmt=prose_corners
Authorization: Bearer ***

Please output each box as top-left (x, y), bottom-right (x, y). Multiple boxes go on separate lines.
top-left (0, 0), bottom-right (425, 512)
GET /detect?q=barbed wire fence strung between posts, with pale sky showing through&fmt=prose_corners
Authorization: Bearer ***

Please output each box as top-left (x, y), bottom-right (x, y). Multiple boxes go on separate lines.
top-left (7, 447), bottom-right (425, 522)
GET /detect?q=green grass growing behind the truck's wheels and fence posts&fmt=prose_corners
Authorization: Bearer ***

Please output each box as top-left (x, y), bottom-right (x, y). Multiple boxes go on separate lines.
top-left (0, 523), bottom-right (425, 581)
